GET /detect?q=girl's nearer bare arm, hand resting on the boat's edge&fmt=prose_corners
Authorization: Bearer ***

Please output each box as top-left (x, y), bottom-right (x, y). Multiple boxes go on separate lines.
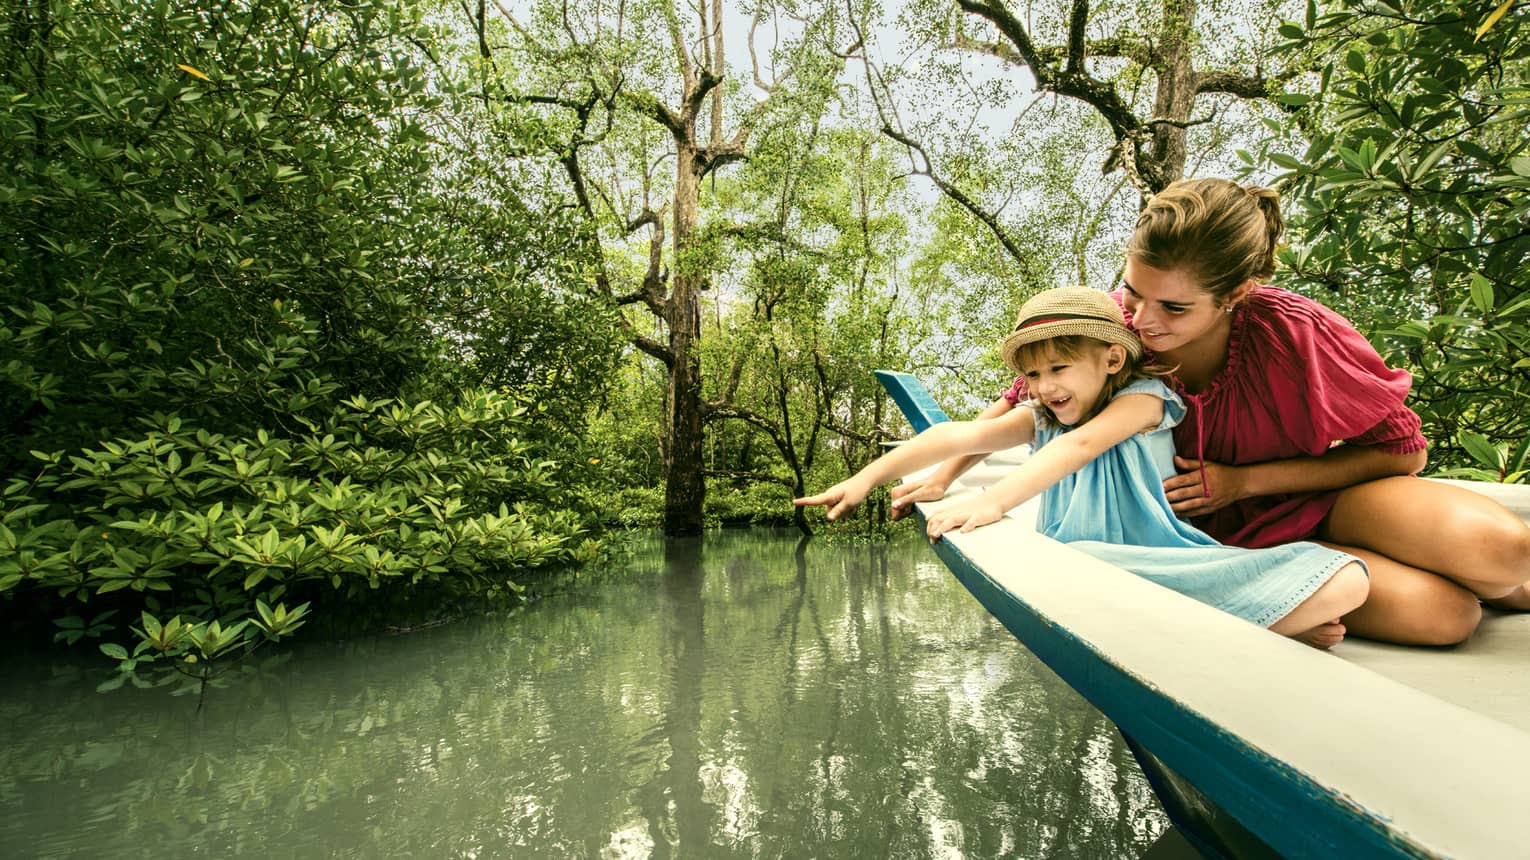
top-left (926, 395), bottom-right (1163, 540)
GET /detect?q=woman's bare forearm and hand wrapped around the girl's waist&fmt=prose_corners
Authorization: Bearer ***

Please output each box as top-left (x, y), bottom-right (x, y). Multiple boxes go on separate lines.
top-left (1163, 445), bottom-right (1429, 517)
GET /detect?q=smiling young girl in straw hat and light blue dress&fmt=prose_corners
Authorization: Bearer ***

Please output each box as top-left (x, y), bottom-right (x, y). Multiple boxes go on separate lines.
top-left (793, 288), bottom-right (1368, 647)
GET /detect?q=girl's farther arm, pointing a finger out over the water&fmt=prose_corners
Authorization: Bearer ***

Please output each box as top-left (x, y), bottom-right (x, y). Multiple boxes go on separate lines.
top-left (791, 409), bottom-right (1036, 520)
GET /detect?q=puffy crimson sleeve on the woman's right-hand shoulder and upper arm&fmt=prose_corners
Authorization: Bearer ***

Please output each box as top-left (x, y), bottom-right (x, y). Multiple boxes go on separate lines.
top-left (1244, 288), bottom-right (1427, 456)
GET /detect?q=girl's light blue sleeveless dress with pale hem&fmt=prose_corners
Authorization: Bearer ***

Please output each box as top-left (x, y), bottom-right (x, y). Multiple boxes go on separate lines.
top-left (1031, 380), bottom-right (1359, 627)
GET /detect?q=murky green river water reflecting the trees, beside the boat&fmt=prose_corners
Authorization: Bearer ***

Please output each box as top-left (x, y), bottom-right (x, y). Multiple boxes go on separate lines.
top-left (0, 529), bottom-right (1166, 858)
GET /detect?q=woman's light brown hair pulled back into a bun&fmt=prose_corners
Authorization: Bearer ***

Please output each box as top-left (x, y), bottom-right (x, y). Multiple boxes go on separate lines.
top-left (1126, 179), bottom-right (1285, 301)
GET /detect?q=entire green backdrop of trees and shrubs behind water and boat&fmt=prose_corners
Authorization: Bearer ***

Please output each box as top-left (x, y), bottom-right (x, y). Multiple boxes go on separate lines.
top-left (0, 0), bottom-right (1530, 673)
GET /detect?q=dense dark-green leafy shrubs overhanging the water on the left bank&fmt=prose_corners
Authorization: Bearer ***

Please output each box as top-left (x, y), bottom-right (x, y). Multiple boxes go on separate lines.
top-left (0, 0), bottom-right (615, 676)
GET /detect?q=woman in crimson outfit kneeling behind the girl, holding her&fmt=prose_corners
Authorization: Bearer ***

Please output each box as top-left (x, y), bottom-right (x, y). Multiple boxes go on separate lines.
top-left (895, 179), bottom-right (1530, 644)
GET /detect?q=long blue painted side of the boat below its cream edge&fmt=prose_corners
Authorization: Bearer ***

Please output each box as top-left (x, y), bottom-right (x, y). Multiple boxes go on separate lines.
top-left (920, 523), bottom-right (1434, 860)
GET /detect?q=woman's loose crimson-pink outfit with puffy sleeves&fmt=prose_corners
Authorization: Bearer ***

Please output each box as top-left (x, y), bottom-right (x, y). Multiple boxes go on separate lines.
top-left (1005, 286), bottom-right (1427, 546)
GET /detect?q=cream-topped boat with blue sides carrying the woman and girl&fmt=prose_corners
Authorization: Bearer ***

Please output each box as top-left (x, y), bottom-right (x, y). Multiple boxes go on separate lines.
top-left (878, 372), bottom-right (1530, 860)
